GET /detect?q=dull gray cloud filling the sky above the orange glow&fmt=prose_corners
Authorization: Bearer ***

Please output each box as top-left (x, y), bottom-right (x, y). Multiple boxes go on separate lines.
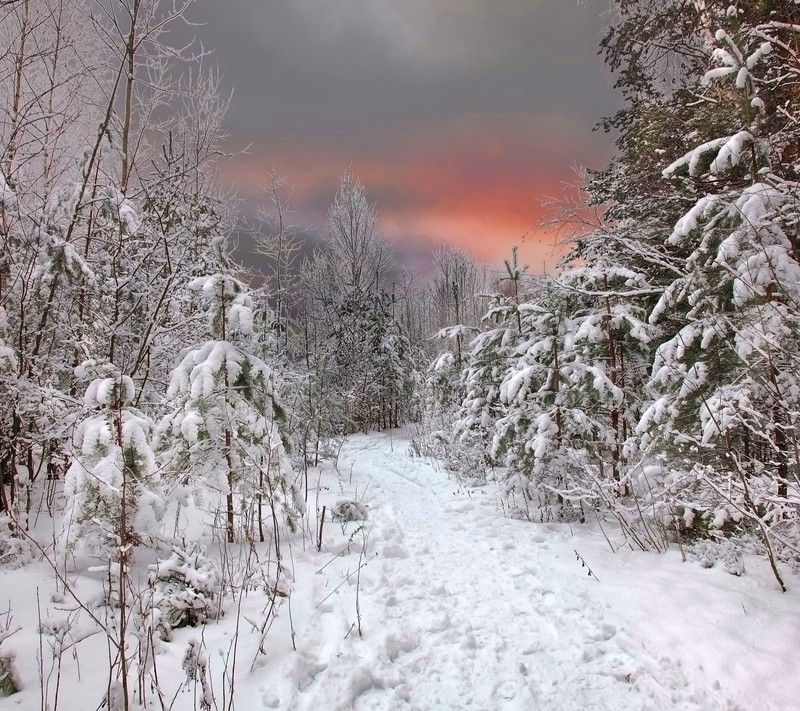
top-left (193, 0), bottom-right (616, 142)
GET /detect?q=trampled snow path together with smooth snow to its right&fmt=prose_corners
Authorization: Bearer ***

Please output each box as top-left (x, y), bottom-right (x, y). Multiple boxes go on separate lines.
top-left (268, 435), bottom-right (800, 710)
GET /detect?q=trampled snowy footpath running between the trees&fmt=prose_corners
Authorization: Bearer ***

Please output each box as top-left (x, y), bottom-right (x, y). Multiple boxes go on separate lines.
top-left (276, 435), bottom-right (735, 711)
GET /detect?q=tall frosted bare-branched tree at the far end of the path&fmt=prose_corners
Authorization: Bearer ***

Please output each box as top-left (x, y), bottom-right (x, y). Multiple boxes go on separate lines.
top-left (303, 171), bottom-right (413, 433)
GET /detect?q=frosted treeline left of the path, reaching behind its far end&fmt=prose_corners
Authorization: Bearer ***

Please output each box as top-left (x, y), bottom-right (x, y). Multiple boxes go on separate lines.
top-left (0, 0), bottom-right (494, 558)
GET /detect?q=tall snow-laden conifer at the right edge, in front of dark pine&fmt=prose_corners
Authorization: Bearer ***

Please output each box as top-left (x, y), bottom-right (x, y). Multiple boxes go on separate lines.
top-left (640, 8), bottom-right (800, 580)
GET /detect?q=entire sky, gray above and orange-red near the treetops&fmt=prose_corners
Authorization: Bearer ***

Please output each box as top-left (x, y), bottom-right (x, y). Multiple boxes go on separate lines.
top-left (192, 0), bottom-right (618, 271)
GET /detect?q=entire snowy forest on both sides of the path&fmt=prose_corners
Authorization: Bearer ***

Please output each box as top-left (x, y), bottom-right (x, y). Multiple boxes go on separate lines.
top-left (0, 0), bottom-right (800, 711)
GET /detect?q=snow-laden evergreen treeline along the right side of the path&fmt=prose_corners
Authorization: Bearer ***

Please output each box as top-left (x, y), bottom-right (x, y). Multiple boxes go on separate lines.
top-left (428, 0), bottom-right (800, 585)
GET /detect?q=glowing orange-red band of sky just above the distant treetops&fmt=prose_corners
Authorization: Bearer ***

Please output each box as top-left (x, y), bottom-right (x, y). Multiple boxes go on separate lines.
top-left (223, 116), bottom-right (608, 271)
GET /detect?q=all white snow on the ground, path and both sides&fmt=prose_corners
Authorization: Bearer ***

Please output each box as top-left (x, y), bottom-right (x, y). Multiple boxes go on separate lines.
top-left (0, 432), bottom-right (800, 711)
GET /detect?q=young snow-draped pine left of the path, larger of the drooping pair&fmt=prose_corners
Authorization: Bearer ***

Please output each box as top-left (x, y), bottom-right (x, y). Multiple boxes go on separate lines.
top-left (158, 274), bottom-right (300, 541)
